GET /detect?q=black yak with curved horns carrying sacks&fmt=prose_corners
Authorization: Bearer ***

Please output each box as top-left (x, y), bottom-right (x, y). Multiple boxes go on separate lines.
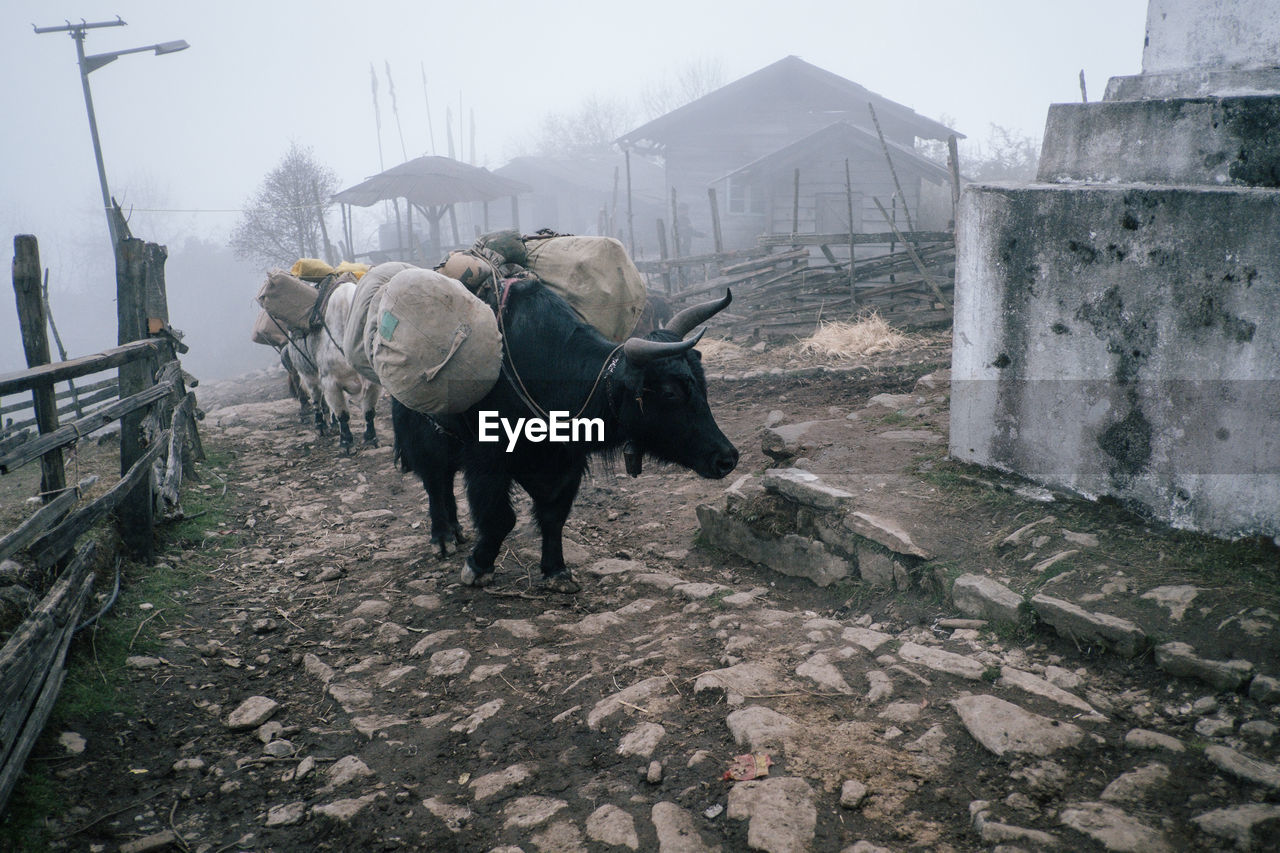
top-left (392, 279), bottom-right (739, 593)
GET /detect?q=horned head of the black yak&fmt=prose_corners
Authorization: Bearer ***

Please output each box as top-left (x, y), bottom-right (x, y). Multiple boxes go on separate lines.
top-left (618, 292), bottom-right (739, 479)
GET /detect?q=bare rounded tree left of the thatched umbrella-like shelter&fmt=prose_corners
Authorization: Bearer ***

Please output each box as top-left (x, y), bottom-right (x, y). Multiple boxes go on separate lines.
top-left (228, 141), bottom-right (338, 266)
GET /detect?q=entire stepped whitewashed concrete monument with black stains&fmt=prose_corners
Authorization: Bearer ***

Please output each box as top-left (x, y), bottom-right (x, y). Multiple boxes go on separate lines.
top-left (951, 0), bottom-right (1280, 537)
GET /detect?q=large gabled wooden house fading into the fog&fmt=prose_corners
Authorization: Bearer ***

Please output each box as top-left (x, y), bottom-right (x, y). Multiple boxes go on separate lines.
top-left (617, 56), bottom-right (960, 255)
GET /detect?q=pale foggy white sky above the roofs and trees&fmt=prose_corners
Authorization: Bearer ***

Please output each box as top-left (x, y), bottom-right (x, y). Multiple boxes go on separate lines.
top-left (0, 0), bottom-right (1147, 378)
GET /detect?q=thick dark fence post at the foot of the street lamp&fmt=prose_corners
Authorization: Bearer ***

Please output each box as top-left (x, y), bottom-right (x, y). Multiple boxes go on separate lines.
top-left (115, 237), bottom-right (155, 561)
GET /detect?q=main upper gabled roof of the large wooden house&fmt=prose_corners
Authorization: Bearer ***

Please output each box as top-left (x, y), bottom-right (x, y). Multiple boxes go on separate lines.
top-left (617, 56), bottom-right (964, 151)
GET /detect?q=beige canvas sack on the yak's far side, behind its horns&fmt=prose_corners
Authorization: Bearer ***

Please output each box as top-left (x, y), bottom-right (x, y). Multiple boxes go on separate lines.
top-left (525, 237), bottom-right (648, 341)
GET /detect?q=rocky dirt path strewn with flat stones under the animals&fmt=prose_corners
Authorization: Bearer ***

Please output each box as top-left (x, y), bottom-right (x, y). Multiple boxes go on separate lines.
top-left (12, 342), bottom-right (1280, 853)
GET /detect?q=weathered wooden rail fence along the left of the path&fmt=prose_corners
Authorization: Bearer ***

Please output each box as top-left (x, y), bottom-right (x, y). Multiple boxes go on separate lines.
top-left (0, 229), bottom-right (202, 809)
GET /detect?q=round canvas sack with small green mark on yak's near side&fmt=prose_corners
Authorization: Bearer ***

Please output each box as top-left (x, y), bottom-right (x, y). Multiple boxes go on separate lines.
top-left (370, 269), bottom-right (502, 415)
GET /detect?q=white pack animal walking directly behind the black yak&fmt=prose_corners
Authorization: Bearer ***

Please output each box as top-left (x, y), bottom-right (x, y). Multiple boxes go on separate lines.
top-left (285, 282), bottom-right (383, 453)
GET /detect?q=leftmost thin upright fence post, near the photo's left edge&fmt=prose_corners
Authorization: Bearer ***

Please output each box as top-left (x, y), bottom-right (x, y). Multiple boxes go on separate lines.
top-left (13, 234), bottom-right (67, 503)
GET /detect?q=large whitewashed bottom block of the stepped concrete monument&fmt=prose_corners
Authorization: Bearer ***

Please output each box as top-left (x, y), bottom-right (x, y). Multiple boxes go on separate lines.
top-left (951, 184), bottom-right (1280, 535)
